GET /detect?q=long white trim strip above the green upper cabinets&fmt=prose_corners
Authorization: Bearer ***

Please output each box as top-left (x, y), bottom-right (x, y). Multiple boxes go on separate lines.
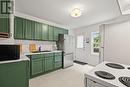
top-left (14, 12), bottom-right (71, 29)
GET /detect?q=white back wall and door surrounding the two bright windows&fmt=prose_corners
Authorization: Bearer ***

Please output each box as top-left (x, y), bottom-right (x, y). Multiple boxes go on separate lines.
top-left (74, 24), bottom-right (100, 65)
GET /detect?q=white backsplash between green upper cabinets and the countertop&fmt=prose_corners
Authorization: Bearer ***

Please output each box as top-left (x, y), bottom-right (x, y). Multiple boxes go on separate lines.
top-left (0, 38), bottom-right (57, 54)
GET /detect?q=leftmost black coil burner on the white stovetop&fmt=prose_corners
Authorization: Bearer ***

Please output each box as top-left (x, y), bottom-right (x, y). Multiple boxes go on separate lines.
top-left (95, 71), bottom-right (115, 80)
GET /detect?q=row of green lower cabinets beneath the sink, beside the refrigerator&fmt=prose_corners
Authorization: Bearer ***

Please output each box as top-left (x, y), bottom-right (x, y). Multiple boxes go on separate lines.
top-left (28, 52), bottom-right (62, 78)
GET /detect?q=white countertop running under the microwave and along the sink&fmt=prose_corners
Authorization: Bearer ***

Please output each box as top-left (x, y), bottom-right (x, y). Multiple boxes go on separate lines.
top-left (0, 50), bottom-right (62, 64)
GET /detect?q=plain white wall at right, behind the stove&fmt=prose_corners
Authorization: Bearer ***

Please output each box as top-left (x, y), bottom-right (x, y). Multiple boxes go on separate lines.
top-left (104, 21), bottom-right (130, 65)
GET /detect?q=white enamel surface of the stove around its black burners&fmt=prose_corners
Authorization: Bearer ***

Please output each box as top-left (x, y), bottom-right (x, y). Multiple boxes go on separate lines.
top-left (85, 61), bottom-right (130, 87)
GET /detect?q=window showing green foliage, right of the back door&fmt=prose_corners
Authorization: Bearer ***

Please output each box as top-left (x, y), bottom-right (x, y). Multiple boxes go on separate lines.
top-left (91, 32), bottom-right (100, 54)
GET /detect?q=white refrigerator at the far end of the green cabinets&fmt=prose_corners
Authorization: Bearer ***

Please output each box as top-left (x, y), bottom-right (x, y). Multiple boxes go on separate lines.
top-left (57, 34), bottom-right (74, 68)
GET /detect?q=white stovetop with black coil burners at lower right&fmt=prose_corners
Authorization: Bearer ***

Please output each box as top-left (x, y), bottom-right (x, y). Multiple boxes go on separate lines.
top-left (85, 61), bottom-right (130, 87)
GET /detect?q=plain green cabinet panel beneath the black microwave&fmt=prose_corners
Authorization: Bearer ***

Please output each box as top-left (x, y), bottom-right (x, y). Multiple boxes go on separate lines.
top-left (0, 61), bottom-right (29, 87)
